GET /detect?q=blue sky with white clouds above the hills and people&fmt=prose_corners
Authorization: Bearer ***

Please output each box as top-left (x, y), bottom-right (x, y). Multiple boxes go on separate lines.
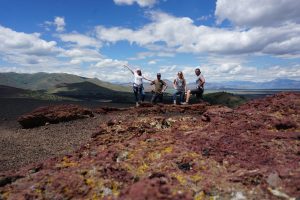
top-left (0, 0), bottom-right (300, 82)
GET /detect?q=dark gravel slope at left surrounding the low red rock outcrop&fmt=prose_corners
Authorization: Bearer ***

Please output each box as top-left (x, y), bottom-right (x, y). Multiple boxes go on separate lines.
top-left (0, 98), bottom-right (129, 172)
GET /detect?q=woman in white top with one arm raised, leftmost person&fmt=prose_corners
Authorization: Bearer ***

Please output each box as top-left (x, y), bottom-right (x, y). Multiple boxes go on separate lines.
top-left (124, 65), bottom-right (151, 107)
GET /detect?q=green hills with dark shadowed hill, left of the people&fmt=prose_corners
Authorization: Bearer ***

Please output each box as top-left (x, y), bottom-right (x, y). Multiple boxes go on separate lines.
top-left (0, 73), bottom-right (133, 102)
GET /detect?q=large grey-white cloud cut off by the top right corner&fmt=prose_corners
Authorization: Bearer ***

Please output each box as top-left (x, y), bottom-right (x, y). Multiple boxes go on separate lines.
top-left (215, 0), bottom-right (300, 26)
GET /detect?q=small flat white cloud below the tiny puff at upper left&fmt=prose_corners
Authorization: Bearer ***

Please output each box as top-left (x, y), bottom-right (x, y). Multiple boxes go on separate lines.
top-left (57, 33), bottom-right (101, 48)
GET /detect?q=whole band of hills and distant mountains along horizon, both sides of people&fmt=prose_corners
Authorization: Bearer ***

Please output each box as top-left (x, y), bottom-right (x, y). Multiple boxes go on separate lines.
top-left (0, 72), bottom-right (300, 93)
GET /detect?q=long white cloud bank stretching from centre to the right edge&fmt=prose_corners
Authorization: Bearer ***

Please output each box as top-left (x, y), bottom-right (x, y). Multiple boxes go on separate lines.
top-left (96, 12), bottom-right (300, 55)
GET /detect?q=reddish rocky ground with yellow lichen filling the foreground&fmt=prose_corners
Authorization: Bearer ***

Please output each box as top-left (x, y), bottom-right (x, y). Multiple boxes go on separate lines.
top-left (0, 93), bottom-right (300, 200)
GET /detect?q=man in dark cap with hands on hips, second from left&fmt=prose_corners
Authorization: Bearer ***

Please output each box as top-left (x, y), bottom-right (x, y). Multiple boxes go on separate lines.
top-left (151, 73), bottom-right (168, 104)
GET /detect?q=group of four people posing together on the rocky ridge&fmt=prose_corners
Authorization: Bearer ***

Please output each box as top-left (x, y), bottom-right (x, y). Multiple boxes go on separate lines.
top-left (124, 65), bottom-right (205, 106)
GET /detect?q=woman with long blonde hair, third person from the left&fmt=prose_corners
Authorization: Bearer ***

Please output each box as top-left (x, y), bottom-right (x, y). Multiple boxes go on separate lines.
top-left (173, 71), bottom-right (186, 105)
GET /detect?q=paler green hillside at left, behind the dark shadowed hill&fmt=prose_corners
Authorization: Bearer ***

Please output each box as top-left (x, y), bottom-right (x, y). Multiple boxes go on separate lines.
top-left (0, 72), bottom-right (130, 92)
